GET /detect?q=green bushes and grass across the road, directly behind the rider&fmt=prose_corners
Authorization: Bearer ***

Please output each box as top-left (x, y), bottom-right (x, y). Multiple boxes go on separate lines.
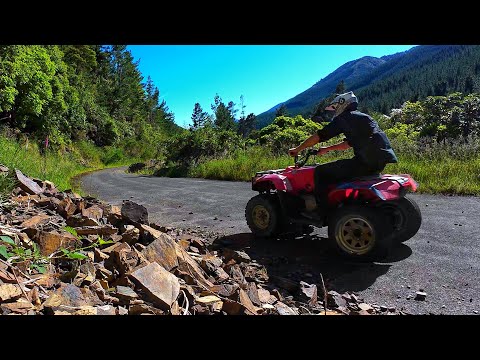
top-left (157, 93), bottom-right (480, 195)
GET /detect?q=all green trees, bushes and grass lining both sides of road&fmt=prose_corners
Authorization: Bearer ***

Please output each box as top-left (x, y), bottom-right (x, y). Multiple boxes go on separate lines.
top-left (0, 45), bottom-right (480, 195)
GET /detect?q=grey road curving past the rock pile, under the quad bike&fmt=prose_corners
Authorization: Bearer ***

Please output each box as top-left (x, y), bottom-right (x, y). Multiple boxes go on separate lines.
top-left (81, 169), bottom-right (480, 315)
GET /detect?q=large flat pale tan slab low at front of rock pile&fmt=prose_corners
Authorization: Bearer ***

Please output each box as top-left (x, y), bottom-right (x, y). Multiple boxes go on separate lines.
top-left (130, 262), bottom-right (180, 310)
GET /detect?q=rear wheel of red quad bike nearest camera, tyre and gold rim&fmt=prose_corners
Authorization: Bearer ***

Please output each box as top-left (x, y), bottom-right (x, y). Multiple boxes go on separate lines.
top-left (328, 206), bottom-right (393, 261)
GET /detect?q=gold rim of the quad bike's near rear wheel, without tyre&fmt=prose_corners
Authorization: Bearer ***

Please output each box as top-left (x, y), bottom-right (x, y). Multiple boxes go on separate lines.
top-left (337, 217), bottom-right (375, 255)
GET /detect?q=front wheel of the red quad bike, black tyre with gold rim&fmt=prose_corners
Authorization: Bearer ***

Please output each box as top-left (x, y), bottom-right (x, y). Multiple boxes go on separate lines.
top-left (245, 194), bottom-right (280, 237)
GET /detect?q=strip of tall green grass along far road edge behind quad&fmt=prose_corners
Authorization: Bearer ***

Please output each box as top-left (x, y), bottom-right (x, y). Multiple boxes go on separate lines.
top-left (189, 138), bottom-right (480, 195)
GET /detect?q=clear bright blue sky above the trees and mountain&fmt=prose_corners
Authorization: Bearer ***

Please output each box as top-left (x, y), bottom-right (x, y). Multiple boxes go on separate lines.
top-left (128, 45), bottom-right (413, 126)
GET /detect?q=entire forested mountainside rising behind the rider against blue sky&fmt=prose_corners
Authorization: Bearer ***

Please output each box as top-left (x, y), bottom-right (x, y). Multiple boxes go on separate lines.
top-left (257, 45), bottom-right (480, 127)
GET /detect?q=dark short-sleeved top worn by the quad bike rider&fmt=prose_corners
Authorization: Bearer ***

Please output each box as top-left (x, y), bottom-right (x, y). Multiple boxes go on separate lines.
top-left (317, 110), bottom-right (398, 169)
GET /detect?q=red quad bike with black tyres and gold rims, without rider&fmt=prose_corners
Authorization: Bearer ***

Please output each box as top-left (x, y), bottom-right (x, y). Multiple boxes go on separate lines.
top-left (245, 149), bottom-right (422, 261)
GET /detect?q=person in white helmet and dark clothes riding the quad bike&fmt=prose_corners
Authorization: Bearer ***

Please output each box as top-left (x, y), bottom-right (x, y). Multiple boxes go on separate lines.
top-left (288, 91), bottom-right (398, 214)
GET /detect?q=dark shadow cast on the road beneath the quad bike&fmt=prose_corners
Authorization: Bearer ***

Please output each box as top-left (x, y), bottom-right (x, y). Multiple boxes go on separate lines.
top-left (212, 233), bottom-right (412, 292)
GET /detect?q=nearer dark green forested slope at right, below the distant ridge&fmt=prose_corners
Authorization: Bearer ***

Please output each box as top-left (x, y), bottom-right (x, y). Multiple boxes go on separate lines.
top-left (354, 45), bottom-right (480, 114)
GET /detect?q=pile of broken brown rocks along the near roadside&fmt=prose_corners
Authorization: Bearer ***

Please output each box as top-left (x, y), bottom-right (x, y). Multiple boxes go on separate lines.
top-left (0, 167), bottom-right (404, 315)
